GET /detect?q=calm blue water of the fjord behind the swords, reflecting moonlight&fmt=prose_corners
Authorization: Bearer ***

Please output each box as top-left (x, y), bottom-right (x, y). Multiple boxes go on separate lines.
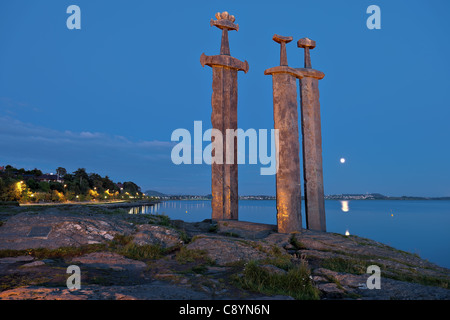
top-left (130, 200), bottom-right (450, 268)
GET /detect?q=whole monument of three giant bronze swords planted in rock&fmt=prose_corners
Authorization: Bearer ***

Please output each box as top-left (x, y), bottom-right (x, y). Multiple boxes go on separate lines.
top-left (200, 12), bottom-right (326, 233)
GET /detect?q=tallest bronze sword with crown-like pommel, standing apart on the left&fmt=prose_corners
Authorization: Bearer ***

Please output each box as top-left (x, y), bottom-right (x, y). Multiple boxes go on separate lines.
top-left (200, 12), bottom-right (248, 220)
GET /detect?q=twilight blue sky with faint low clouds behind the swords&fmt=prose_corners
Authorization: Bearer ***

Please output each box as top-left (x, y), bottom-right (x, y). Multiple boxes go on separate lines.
top-left (0, 0), bottom-right (450, 196)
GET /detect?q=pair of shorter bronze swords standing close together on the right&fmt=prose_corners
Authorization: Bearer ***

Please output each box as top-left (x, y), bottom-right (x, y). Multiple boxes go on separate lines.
top-left (264, 35), bottom-right (326, 232)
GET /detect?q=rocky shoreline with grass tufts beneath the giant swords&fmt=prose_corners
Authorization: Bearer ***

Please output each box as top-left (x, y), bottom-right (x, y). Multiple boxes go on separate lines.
top-left (0, 206), bottom-right (450, 300)
